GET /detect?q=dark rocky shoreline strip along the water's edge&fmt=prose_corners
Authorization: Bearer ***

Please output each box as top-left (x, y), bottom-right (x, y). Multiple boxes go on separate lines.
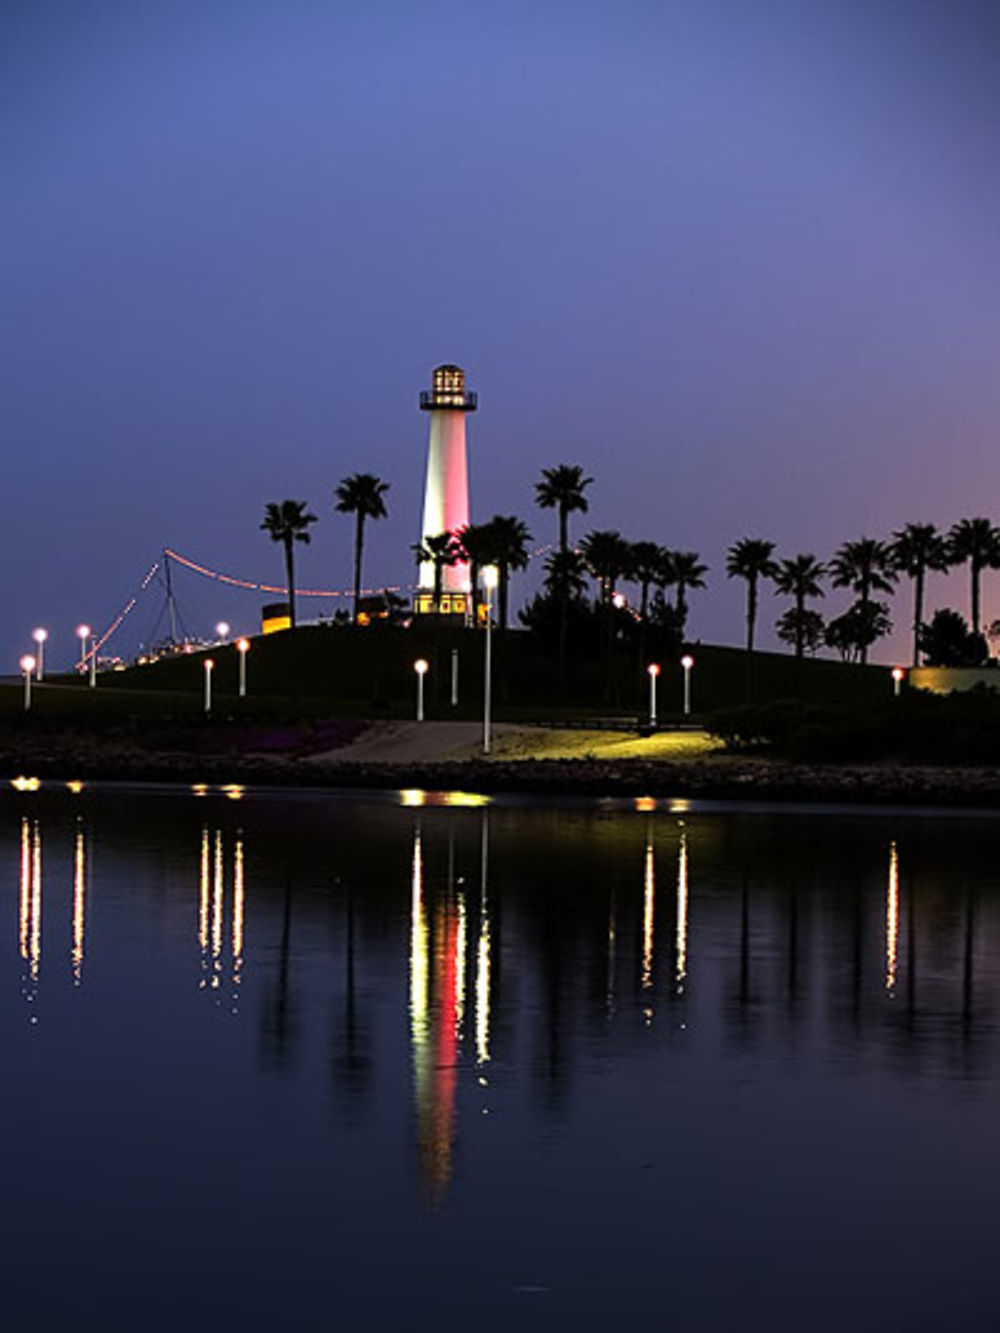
top-left (0, 738), bottom-right (1000, 808)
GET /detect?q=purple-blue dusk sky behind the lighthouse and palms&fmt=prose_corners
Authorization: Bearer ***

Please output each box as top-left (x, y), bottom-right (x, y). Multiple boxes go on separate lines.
top-left (0, 0), bottom-right (1000, 670)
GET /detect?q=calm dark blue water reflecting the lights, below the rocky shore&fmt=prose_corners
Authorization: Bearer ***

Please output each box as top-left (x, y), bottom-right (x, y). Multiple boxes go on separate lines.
top-left (0, 784), bottom-right (1000, 1330)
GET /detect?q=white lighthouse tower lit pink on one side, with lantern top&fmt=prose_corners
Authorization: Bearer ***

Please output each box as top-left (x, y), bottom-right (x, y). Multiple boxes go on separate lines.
top-left (415, 365), bottom-right (477, 615)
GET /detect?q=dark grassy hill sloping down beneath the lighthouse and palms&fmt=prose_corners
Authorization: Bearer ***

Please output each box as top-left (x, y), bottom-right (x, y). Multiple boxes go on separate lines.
top-left (0, 623), bottom-right (892, 726)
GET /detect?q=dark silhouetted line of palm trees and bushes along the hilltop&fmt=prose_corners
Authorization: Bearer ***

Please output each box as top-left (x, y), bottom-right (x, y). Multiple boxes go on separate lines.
top-left (261, 463), bottom-right (1000, 674)
